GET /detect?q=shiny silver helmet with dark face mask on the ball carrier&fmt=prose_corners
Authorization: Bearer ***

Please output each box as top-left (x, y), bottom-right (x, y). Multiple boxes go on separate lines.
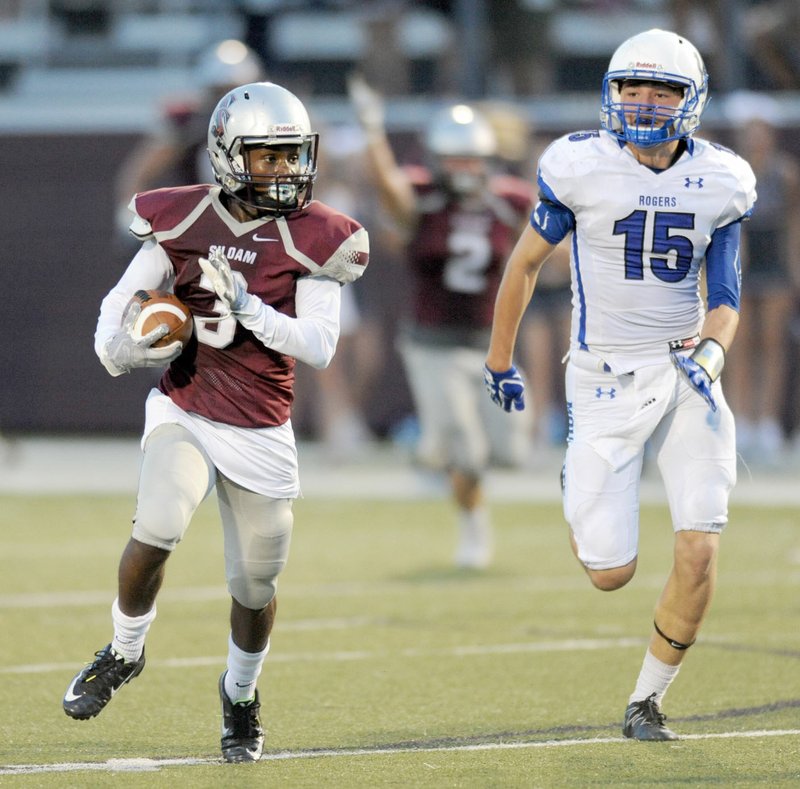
top-left (208, 82), bottom-right (319, 214)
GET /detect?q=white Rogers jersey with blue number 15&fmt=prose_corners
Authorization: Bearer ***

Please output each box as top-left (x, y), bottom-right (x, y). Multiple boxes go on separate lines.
top-left (532, 131), bottom-right (756, 374)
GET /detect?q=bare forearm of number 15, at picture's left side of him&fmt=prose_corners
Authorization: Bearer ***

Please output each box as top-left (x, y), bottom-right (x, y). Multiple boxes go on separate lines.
top-left (486, 226), bottom-right (555, 371)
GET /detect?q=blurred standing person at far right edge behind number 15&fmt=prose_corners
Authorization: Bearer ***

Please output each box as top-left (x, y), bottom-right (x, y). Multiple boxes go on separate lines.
top-left (725, 91), bottom-right (800, 463)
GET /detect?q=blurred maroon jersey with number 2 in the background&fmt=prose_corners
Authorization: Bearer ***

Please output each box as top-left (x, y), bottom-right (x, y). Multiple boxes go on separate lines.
top-left (408, 168), bottom-right (534, 336)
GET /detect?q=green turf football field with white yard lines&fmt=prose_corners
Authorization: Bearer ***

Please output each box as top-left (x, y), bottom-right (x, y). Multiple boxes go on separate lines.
top-left (0, 496), bottom-right (800, 789)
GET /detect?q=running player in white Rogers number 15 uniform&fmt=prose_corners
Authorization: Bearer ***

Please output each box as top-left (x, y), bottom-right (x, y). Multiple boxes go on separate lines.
top-left (484, 29), bottom-right (756, 740)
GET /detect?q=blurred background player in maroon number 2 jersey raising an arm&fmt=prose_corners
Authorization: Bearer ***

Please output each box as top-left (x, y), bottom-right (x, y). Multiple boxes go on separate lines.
top-left (349, 76), bottom-right (534, 569)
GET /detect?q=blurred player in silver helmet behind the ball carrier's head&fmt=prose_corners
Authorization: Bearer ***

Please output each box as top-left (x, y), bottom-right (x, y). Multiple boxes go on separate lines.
top-left (115, 39), bottom-right (266, 245)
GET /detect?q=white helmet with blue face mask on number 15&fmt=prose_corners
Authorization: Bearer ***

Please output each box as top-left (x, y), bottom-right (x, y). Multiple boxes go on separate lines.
top-left (600, 28), bottom-right (708, 148)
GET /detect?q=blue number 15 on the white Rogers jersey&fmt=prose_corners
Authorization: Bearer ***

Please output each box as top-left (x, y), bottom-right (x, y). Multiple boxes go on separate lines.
top-left (614, 211), bottom-right (694, 282)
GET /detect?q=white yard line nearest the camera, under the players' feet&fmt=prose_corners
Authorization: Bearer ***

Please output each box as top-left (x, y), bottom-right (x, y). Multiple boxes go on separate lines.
top-left (0, 729), bottom-right (800, 775)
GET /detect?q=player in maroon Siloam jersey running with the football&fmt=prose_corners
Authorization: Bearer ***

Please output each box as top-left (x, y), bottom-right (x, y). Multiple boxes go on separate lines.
top-left (63, 82), bottom-right (368, 762)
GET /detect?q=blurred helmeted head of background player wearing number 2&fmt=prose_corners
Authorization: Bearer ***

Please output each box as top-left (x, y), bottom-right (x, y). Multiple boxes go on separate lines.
top-left (424, 104), bottom-right (497, 194)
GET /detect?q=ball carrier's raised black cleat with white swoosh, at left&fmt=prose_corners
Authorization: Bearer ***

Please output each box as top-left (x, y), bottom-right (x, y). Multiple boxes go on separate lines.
top-left (64, 644), bottom-right (144, 720)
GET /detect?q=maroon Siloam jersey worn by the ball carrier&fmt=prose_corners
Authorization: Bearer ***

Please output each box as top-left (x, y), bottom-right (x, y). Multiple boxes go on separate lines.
top-left (132, 185), bottom-right (367, 427)
